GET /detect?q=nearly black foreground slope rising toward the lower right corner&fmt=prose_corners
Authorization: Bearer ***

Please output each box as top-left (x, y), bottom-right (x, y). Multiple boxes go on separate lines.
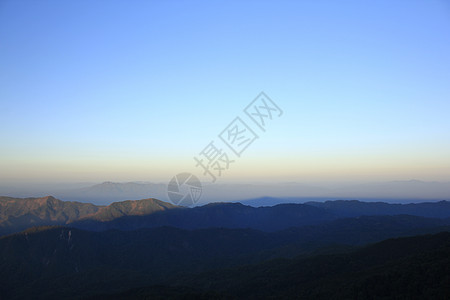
top-left (116, 232), bottom-right (450, 300)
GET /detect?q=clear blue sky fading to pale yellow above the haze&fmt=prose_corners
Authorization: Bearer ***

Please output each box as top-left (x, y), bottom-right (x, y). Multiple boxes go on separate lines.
top-left (0, 0), bottom-right (450, 188)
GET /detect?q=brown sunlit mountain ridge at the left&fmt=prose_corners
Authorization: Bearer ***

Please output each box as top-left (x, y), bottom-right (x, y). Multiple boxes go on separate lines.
top-left (0, 196), bottom-right (176, 235)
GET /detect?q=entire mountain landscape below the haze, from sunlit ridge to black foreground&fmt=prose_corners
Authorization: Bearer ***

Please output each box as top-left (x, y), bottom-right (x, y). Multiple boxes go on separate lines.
top-left (0, 196), bottom-right (450, 299)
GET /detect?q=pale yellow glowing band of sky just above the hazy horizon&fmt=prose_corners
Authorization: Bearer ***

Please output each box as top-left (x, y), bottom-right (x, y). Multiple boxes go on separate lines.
top-left (0, 147), bottom-right (450, 182)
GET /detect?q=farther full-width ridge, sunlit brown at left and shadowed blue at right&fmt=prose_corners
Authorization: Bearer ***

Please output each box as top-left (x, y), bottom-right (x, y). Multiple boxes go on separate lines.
top-left (0, 196), bottom-right (450, 235)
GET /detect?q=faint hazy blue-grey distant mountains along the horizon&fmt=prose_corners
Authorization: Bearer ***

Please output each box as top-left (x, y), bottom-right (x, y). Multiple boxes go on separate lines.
top-left (0, 178), bottom-right (450, 206)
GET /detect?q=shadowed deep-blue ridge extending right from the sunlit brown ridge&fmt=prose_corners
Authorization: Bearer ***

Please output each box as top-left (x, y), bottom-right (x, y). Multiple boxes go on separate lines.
top-left (71, 201), bottom-right (450, 231)
